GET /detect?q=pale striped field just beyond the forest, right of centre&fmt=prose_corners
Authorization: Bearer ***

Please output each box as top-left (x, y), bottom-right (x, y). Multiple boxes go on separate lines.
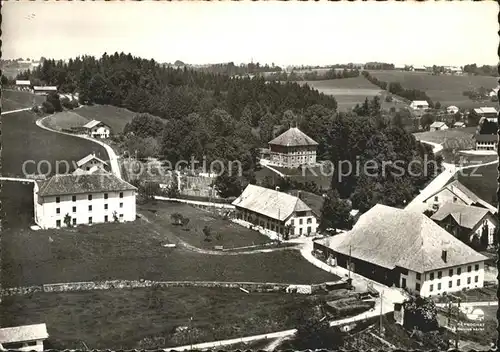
top-left (301, 76), bottom-right (382, 111)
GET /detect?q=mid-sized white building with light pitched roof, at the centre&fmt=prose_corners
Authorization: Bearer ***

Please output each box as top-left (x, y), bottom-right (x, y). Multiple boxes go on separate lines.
top-left (232, 185), bottom-right (318, 237)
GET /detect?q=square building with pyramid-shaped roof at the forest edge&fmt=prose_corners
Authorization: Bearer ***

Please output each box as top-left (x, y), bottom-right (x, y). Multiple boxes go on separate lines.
top-left (269, 127), bottom-right (318, 168)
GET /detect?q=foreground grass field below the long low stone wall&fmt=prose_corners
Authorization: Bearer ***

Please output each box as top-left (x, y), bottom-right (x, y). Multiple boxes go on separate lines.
top-left (0, 287), bottom-right (315, 350)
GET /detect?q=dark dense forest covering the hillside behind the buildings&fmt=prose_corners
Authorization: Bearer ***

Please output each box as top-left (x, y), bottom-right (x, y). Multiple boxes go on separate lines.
top-left (18, 53), bottom-right (442, 210)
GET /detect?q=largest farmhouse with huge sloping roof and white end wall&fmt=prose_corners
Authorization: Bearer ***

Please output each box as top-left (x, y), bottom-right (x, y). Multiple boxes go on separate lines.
top-left (314, 204), bottom-right (487, 297)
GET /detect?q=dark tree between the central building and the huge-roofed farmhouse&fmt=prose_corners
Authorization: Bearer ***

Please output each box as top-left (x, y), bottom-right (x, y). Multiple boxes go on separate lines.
top-left (318, 190), bottom-right (353, 232)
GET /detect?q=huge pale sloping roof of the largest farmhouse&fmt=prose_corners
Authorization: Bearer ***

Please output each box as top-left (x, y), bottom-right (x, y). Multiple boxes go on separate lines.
top-left (316, 204), bottom-right (487, 273)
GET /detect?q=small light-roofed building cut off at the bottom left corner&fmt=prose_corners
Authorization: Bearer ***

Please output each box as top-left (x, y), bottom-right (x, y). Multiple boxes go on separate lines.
top-left (0, 324), bottom-right (49, 352)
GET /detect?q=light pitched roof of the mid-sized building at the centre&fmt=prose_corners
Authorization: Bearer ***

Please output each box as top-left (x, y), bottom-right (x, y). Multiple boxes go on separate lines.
top-left (232, 185), bottom-right (311, 221)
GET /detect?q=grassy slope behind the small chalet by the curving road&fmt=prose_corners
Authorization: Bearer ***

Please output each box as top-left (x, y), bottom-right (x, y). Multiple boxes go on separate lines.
top-left (74, 105), bottom-right (136, 133)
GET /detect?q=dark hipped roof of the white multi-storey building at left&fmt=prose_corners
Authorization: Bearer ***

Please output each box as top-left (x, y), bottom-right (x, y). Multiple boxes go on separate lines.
top-left (38, 172), bottom-right (137, 197)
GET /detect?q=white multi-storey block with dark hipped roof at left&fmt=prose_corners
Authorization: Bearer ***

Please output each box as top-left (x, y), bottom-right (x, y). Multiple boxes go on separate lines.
top-left (33, 172), bottom-right (137, 229)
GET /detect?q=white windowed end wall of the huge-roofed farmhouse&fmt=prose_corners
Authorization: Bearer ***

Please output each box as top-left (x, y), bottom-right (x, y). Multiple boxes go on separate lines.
top-left (420, 262), bottom-right (484, 297)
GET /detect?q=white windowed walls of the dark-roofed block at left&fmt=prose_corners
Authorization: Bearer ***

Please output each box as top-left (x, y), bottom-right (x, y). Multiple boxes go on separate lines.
top-left (37, 191), bottom-right (136, 228)
